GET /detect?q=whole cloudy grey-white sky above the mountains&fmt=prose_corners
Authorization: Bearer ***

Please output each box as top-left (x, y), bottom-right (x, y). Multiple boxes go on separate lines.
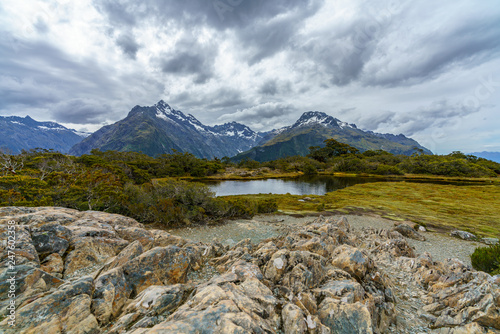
top-left (0, 0), bottom-right (500, 154)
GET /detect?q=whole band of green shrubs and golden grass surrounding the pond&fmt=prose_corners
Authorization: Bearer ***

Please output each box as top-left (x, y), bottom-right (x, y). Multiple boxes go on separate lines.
top-left (0, 145), bottom-right (500, 231)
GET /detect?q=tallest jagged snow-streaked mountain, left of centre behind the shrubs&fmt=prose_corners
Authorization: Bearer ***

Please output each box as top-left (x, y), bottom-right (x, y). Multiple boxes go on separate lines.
top-left (70, 100), bottom-right (261, 159)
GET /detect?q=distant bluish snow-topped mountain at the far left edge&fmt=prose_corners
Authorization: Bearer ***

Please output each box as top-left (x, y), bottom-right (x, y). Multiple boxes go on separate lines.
top-left (0, 116), bottom-right (88, 154)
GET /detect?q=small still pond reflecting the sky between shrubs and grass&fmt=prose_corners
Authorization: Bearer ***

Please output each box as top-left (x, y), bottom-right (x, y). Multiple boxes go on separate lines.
top-left (204, 175), bottom-right (486, 196)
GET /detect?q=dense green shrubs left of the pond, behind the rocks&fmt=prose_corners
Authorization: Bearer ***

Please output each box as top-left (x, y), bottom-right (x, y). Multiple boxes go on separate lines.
top-left (0, 150), bottom-right (277, 226)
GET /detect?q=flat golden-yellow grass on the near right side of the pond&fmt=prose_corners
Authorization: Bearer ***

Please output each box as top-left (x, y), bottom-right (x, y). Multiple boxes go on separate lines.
top-left (226, 182), bottom-right (500, 237)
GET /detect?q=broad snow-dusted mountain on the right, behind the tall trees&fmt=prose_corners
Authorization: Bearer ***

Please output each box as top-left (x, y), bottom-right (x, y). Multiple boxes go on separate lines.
top-left (234, 111), bottom-right (431, 161)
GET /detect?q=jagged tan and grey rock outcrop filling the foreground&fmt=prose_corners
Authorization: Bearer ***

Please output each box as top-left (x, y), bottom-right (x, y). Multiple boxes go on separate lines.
top-left (0, 207), bottom-right (500, 334)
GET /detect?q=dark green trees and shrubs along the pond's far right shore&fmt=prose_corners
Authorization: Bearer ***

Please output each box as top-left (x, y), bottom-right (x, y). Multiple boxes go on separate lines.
top-left (234, 139), bottom-right (500, 177)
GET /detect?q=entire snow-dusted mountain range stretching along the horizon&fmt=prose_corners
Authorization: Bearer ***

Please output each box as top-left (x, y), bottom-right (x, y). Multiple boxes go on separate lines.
top-left (0, 100), bottom-right (432, 161)
